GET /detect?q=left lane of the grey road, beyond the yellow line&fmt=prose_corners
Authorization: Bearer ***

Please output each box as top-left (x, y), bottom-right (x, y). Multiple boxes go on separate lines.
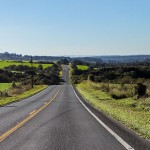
top-left (0, 86), bottom-right (60, 139)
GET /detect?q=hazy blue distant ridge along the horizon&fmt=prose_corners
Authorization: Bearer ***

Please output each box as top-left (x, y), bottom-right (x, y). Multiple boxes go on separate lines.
top-left (0, 52), bottom-right (150, 63)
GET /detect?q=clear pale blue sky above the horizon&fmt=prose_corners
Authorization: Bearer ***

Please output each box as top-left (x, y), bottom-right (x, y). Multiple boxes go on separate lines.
top-left (0, 0), bottom-right (150, 56)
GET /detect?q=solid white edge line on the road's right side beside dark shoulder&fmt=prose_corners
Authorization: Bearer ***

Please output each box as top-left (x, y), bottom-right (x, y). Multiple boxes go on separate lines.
top-left (71, 85), bottom-right (135, 150)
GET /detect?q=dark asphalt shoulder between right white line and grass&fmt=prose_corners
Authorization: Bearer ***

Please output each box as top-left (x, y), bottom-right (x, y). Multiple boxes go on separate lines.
top-left (74, 87), bottom-right (150, 150)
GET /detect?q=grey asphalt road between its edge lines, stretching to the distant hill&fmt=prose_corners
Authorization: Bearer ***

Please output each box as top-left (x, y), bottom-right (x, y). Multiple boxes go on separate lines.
top-left (0, 66), bottom-right (142, 150)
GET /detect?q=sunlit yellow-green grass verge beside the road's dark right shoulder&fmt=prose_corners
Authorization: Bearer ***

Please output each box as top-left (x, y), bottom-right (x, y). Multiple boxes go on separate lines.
top-left (76, 82), bottom-right (150, 139)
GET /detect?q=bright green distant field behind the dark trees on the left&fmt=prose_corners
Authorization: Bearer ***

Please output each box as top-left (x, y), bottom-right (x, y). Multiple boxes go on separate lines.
top-left (0, 61), bottom-right (52, 69)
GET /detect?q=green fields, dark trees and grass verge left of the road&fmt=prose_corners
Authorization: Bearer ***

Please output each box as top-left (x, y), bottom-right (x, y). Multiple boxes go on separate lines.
top-left (0, 61), bottom-right (61, 105)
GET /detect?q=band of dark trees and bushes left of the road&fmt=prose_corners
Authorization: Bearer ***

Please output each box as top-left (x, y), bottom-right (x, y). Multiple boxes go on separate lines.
top-left (0, 63), bottom-right (61, 85)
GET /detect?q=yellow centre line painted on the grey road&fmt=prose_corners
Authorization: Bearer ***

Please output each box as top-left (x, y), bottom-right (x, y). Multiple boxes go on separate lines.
top-left (0, 89), bottom-right (61, 142)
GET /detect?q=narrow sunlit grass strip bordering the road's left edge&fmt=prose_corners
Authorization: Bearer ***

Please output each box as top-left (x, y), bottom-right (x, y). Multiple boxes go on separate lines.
top-left (0, 85), bottom-right (47, 106)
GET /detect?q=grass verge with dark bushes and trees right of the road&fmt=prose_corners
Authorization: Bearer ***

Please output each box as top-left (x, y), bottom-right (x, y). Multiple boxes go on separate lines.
top-left (71, 59), bottom-right (150, 139)
